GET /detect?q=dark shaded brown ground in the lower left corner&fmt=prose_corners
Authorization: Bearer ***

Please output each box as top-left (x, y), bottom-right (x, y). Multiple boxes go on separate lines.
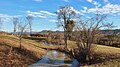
top-left (0, 43), bottom-right (40, 67)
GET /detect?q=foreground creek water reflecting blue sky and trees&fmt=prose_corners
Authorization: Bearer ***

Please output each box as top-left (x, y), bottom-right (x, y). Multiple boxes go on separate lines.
top-left (29, 50), bottom-right (79, 67)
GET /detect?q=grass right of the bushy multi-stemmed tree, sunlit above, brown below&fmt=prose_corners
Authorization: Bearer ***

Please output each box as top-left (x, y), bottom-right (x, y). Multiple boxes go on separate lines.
top-left (82, 45), bottom-right (120, 67)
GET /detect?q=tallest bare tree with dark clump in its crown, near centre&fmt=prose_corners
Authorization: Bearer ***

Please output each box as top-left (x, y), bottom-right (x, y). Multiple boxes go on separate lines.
top-left (57, 6), bottom-right (75, 49)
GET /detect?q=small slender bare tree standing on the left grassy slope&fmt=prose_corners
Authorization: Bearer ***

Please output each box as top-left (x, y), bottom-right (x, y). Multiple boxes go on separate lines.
top-left (18, 22), bottom-right (28, 49)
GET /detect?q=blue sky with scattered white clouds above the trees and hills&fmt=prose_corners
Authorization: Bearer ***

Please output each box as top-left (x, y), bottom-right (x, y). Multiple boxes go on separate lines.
top-left (0, 0), bottom-right (120, 32)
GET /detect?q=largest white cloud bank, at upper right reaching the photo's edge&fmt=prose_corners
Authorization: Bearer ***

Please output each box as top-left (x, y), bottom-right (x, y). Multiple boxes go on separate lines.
top-left (80, 4), bottom-right (120, 15)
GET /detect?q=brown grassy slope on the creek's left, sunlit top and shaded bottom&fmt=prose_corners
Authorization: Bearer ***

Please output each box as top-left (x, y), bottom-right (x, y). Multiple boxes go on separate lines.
top-left (0, 34), bottom-right (45, 67)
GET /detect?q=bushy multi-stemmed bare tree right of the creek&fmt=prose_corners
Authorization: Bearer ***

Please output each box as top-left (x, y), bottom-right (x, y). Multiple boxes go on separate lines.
top-left (70, 14), bottom-right (106, 63)
